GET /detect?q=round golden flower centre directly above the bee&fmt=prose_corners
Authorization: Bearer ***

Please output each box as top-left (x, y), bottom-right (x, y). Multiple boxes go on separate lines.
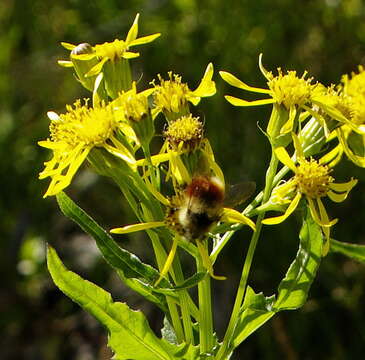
top-left (164, 114), bottom-right (203, 151)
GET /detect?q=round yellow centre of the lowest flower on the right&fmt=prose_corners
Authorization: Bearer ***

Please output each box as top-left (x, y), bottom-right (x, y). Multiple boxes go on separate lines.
top-left (294, 159), bottom-right (334, 199)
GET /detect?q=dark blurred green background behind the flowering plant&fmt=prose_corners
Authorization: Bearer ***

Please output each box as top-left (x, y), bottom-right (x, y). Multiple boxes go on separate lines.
top-left (0, 0), bottom-right (365, 360)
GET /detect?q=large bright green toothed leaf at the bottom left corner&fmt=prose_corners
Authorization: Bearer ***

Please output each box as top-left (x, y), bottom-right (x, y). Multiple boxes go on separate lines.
top-left (47, 247), bottom-right (179, 360)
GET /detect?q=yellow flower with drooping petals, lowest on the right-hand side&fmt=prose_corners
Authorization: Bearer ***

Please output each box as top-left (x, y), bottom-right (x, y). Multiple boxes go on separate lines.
top-left (263, 134), bottom-right (357, 255)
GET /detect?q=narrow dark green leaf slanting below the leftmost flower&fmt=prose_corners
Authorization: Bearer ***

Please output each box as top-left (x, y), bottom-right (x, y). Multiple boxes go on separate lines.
top-left (57, 192), bottom-right (170, 312)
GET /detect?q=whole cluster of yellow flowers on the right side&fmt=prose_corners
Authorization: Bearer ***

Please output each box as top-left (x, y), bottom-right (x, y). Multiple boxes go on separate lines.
top-left (220, 55), bottom-right (365, 254)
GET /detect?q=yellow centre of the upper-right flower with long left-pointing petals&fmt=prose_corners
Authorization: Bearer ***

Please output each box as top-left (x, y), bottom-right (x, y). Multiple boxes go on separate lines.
top-left (268, 68), bottom-right (315, 110)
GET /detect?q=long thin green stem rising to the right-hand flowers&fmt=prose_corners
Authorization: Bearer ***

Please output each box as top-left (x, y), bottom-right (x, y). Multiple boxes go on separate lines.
top-left (216, 151), bottom-right (278, 360)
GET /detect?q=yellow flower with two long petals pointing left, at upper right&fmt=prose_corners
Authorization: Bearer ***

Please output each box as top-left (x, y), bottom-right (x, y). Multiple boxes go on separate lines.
top-left (219, 54), bottom-right (317, 134)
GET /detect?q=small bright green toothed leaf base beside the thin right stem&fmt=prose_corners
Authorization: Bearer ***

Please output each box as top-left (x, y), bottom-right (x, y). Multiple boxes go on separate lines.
top-left (232, 286), bottom-right (275, 348)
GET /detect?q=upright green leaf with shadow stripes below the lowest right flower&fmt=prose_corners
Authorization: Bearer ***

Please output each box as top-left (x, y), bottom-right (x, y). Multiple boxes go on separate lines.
top-left (274, 211), bottom-right (323, 311)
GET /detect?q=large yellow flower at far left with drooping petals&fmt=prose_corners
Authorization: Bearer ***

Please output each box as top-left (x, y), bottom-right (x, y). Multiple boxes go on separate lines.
top-left (38, 100), bottom-right (135, 197)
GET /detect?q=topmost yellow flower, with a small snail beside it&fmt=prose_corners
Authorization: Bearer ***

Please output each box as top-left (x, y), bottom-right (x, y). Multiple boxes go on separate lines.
top-left (59, 14), bottom-right (161, 76)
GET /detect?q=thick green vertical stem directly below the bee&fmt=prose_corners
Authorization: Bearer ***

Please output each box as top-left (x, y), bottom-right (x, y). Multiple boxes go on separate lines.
top-left (196, 241), bottom-right (214, 354)
